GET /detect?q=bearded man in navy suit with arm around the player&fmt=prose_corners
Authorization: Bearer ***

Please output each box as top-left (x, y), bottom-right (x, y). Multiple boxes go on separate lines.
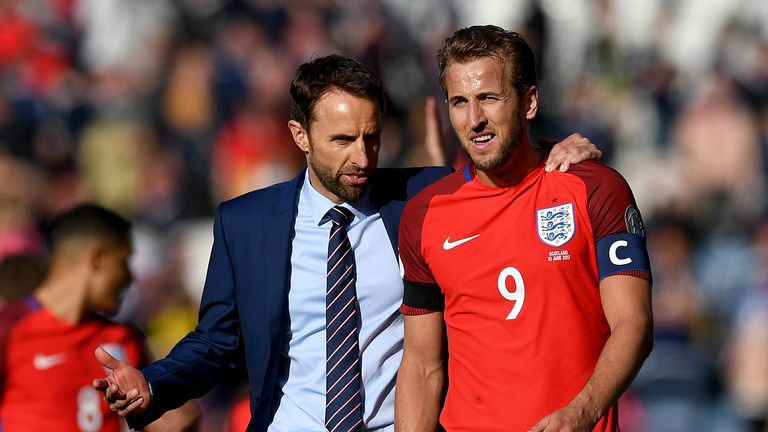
top-left (94, 55), bottom-right (599, 431)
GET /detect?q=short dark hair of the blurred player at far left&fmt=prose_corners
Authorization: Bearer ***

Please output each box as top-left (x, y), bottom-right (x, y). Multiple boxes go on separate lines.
top-left (47, 203), bottom-right (131, 251)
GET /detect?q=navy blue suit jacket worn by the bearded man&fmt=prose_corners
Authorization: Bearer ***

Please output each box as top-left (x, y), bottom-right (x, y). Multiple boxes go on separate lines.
top-left (129, 167), bottom-right (450, 431)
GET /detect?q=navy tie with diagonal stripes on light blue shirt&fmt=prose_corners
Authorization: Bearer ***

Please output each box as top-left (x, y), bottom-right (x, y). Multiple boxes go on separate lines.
top-left (321, 206), bottom-right (363, 432)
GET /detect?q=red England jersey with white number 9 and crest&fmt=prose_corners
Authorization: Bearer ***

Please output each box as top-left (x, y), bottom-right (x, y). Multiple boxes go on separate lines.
top-left (400, 162), bottom-right (650, 431)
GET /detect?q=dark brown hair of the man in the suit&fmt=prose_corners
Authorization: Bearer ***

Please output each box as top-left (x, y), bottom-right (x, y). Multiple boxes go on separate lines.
top-left (289, 54), bottom-right (384, 128)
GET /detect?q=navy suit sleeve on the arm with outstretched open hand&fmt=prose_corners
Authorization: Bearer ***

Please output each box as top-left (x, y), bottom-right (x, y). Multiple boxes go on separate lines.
top-left (129, 206), bottom-right (241, 429)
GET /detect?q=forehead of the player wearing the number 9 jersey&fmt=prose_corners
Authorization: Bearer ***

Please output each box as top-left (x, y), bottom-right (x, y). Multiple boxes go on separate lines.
top-left (445, 57), bottom-right (512, 97)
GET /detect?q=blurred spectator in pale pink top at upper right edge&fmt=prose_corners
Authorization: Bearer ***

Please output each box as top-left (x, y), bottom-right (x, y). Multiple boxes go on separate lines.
top-left (675, 74), bottom-right (765, 227)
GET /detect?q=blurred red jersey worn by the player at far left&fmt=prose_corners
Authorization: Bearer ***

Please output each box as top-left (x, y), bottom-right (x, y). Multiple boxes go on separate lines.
top-left (0, 296), bottom-right (146, 432)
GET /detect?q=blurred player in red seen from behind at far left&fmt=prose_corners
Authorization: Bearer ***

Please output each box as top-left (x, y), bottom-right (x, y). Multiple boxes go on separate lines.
top-left (0, 204), bottom-right (201, 432)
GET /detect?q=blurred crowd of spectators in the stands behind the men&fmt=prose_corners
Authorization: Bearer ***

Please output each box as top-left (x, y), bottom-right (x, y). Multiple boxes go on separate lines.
top-left (0, 0), bottom-right (768, 432)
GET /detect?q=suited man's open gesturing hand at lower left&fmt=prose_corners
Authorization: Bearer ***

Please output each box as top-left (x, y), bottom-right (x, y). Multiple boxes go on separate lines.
top-left (93, 348), bottom-right (152, 417)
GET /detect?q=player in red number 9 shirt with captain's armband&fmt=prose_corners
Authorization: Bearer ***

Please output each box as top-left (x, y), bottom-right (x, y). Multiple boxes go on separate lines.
top-left (395, 26), bottom-right (652, 432)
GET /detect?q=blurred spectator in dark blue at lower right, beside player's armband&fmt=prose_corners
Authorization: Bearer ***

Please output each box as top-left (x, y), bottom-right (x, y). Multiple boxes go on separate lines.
top-left (630, 215), bottom-right (752, 432)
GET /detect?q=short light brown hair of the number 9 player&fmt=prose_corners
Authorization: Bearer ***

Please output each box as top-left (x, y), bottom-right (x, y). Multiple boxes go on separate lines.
top-left (436, 25), bottom-right (536, 94)
